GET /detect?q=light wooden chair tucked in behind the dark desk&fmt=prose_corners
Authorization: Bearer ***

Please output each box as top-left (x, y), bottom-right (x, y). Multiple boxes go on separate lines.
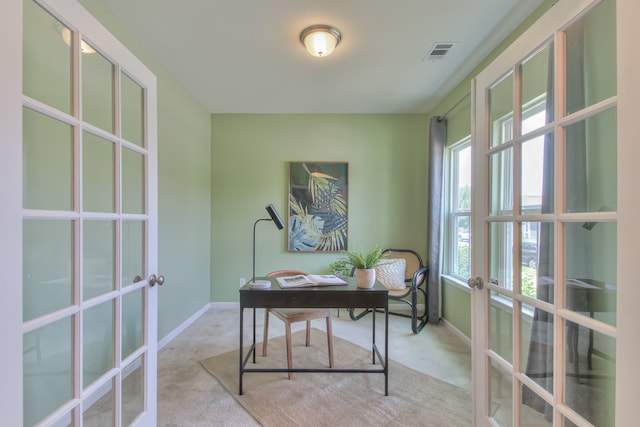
top-left (262, 270), bottom-right (333, 379)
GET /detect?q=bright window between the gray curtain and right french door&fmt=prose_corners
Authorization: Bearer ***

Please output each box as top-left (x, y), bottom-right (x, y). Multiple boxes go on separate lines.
top-left (443, 137), bottom-right (471, 282)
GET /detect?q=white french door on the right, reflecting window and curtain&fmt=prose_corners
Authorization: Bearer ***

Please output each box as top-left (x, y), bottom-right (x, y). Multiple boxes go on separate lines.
top-left (470, 0), bottom-right (640, 426)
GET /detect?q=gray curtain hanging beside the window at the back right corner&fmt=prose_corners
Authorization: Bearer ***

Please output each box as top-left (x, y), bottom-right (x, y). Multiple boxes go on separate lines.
top-left (426, 116), bottom-right (447, 323)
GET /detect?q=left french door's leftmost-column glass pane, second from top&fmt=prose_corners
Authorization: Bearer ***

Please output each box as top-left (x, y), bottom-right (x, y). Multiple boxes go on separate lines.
top-left (22, 107), bottom-right (73, 211)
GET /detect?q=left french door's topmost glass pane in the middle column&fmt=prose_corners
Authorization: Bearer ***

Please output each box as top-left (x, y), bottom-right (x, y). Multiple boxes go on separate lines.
top-left (82, 52), bottom-right (114, 133)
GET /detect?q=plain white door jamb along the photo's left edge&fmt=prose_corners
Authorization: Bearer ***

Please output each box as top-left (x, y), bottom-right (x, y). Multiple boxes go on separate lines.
top-left (0, 0), bottom-right (22, 426)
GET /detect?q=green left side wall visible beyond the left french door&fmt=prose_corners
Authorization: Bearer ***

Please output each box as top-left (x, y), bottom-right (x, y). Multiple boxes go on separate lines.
top-left (79, 0), bottom-right (211, 339)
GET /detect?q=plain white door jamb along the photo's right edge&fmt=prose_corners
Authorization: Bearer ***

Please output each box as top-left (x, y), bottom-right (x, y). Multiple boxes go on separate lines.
top-left (616, 0), bottom-right (640, 426)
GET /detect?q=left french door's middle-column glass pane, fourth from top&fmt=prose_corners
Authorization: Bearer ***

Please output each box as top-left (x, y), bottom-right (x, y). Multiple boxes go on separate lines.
top-left (82, 301), bottom-right (115, 388)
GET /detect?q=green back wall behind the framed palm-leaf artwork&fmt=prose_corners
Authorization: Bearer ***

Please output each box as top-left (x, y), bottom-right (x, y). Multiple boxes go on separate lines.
top-left (211, 114), bottom-right (428, 302)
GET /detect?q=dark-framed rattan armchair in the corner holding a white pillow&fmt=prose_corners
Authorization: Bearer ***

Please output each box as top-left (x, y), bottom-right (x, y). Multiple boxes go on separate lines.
top-left (349, 249), bottom-right (429, 334)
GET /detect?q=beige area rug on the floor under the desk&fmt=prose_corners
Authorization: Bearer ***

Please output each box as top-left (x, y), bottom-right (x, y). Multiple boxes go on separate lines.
top-left (201, 329), bottom-right (471, 427)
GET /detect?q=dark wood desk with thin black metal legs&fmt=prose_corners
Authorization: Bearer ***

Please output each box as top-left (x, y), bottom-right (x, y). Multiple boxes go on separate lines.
top-left (238, 277), bottom-right (389, 396)
